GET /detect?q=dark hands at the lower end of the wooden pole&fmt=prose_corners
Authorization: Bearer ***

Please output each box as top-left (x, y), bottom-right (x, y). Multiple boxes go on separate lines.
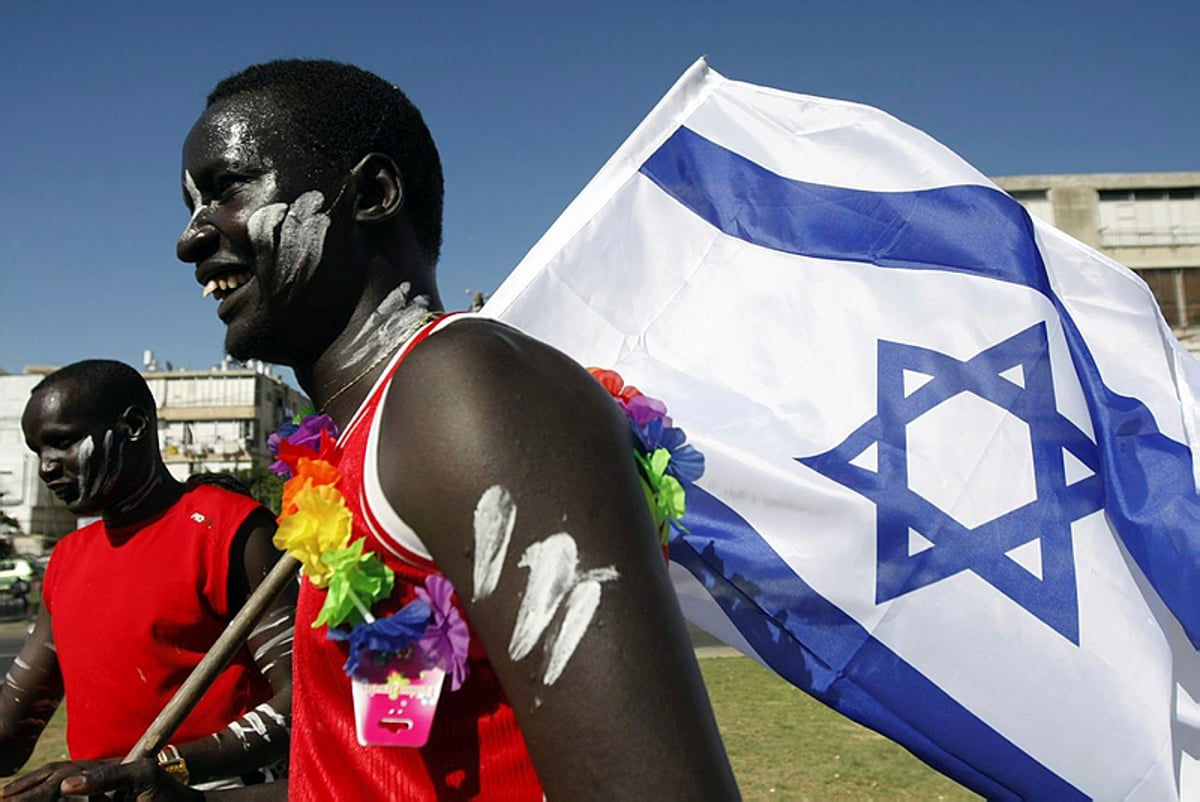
top-left (0, 758), bottom-right (204, 802)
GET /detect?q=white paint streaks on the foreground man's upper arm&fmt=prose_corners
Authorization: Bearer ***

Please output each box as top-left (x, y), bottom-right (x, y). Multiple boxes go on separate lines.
top-left (473, 485), bottom-right (620, 686)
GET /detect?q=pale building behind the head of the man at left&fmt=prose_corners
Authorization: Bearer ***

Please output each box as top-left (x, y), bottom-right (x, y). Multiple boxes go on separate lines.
top-left (0, 363), bottom-right (308, 553)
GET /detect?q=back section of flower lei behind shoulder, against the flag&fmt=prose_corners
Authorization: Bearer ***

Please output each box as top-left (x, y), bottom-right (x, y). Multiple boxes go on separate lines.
top-left (588, 367), bottom-right (704, 546)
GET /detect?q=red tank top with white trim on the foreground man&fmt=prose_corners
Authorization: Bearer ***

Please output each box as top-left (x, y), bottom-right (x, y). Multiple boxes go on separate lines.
top-left (288, 316), bottom-right (544, 802)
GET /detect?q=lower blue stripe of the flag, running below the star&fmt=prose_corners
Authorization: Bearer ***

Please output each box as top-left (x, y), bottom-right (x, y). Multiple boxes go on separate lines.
top-left (671, 485), bottom-right (1087, 800)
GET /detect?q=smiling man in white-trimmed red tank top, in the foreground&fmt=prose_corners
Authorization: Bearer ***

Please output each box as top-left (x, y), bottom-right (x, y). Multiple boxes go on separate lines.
top-left (64, 61), bottom-right (737, 801)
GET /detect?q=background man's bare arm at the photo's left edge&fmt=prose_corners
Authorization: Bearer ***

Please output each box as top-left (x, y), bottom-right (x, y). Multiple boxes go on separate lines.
top-left (0, 605), bottom-right (62, 776)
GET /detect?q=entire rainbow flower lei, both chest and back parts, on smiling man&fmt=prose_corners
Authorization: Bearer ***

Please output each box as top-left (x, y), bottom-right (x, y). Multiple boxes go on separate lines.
top-left (268, 367), bottom-right (704, 690)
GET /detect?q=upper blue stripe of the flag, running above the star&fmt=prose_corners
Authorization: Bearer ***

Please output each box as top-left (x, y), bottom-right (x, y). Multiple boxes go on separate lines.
top-left (641, 128), bottom-right (1200, 648)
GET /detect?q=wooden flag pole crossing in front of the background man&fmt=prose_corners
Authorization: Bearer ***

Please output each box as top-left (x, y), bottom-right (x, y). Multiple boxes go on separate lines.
top-left (121, 555), bottom-right (300, 764)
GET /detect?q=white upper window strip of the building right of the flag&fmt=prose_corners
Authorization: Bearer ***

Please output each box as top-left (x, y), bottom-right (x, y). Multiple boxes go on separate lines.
top-left (1099, 187), bottom-right (1200, 247)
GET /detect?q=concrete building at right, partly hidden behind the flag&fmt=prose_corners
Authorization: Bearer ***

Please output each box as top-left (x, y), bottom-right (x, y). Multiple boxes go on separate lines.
top-left (992, 172), bottom-right (1200, 352)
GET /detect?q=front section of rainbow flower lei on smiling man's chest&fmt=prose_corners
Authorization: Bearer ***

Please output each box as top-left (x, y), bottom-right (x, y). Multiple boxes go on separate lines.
top-left (268, 412), bottom-right (470, 690)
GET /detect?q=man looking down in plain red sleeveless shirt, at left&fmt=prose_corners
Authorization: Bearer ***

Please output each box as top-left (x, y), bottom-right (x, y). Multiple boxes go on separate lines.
top-left (0, 360), bottom-right (295, 800)
